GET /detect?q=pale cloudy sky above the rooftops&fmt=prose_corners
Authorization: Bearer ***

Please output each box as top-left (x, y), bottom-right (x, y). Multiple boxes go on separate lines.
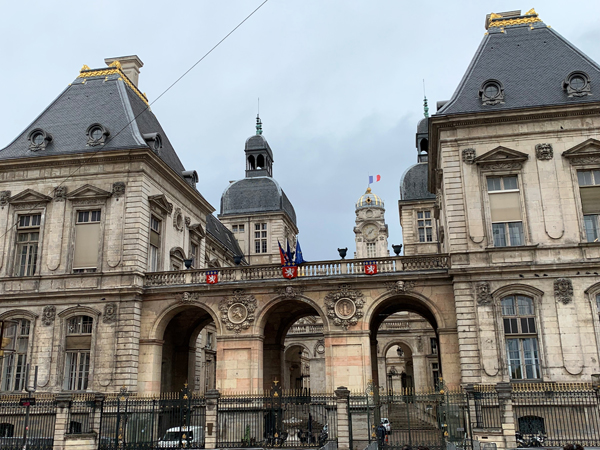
top-left (0, 0), bottom-right (600, 260)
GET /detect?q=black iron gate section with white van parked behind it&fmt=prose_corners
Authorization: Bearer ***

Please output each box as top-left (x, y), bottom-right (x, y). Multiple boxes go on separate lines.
top-left (98, 385), bottom-right (206, 450)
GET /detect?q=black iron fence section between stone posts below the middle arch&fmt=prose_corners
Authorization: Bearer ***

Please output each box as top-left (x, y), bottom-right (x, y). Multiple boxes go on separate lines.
top-left (217, 386), bottom-right (337, 447)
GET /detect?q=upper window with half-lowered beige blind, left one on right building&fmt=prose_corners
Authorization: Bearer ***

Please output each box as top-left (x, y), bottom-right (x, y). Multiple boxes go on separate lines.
top-left (487, 175), bottom-right (525, 247)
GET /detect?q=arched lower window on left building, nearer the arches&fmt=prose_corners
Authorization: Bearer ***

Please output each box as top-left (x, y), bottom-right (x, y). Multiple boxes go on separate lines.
top-left (63, 315), bottom-right (94, 391)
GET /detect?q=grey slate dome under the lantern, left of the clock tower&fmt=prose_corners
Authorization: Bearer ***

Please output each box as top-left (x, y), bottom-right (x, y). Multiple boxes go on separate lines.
top-left (220, 177), bottom-right (296, 224)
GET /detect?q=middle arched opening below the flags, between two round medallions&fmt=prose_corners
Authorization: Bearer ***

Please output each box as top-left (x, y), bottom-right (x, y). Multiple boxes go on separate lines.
top-left (262, 300), bottom-right (324, 390)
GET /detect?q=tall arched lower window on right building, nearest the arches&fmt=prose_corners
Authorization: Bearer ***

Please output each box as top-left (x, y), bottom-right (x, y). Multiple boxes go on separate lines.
top-left (502, 295), bottom-right (541, 380)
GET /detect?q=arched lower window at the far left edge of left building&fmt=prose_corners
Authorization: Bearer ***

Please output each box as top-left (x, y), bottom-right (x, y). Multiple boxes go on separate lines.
top-left (2, 319), bottom-right (31, 391)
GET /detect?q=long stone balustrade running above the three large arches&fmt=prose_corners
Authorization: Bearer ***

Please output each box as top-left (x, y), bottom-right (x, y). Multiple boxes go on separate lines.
top-left (144, 255), bottom-right (450, 287)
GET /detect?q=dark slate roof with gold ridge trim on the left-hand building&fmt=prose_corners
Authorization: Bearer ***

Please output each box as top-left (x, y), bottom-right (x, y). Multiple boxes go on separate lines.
top-left (0, 67), bottom-right (185, 175)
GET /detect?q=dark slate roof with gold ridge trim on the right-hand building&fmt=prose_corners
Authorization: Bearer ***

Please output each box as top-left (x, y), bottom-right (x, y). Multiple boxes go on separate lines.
top-left (436, 17), bottom-right (600, 116)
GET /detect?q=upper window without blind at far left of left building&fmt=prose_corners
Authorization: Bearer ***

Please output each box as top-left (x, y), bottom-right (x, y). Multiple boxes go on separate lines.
top-left (15, 214), bottom-right (42, 277)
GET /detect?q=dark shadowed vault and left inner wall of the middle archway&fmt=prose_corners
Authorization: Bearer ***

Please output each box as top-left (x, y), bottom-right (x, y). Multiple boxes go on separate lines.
top-left (261, 299), bottom-right (327, 390)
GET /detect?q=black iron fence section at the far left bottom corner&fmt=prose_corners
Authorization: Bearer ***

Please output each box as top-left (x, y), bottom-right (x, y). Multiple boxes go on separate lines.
top-left (0, 394), bottom-right (56, 450)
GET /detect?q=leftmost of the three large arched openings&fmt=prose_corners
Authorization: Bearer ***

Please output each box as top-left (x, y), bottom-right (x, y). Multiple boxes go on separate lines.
top-left (160, 305), bottom-right (216, 392)
